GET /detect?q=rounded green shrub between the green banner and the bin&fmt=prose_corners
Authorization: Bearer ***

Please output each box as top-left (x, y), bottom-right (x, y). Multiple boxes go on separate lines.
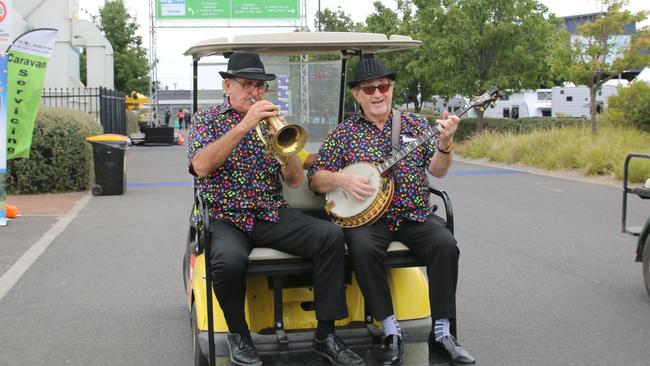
top-left (7, 108), bottom-right (102, 193)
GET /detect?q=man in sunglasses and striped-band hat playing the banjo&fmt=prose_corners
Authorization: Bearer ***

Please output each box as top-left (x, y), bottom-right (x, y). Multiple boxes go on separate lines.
top-left (308, 56), bottom-right (475, 365)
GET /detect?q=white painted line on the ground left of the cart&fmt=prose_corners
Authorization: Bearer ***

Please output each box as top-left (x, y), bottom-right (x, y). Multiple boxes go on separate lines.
top-left (0, 194), bottom-right (91, 301)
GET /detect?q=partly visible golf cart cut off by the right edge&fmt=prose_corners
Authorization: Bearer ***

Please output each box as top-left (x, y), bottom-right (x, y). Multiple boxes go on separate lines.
top-left (621, 154), bottom-right (650, 296)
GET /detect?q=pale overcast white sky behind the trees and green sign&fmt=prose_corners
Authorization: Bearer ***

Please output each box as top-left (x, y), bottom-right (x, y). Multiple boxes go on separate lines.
top-left (78, 0), bottom-right (650, 89)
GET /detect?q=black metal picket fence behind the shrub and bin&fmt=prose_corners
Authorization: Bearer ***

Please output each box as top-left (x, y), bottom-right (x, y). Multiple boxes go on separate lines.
top-left (41, 87), bottom-right (126, 135)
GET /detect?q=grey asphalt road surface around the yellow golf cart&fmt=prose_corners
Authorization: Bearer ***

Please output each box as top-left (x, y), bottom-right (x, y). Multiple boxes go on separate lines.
top-left (0, 146), bottom-right (650, 366)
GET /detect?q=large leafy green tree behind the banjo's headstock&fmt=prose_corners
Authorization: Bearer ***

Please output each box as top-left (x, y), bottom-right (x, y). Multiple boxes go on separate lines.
top-left (413, 0), bottom-right (561, 132)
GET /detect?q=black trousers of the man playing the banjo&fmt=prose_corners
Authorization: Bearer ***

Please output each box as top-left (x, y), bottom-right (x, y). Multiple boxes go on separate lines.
top-left (344, 215), bottom-right (460, 320)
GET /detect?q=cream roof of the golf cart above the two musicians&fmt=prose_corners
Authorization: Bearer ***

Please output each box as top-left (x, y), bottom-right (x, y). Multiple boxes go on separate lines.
top-left (185, 32), bottom-right (421, 60)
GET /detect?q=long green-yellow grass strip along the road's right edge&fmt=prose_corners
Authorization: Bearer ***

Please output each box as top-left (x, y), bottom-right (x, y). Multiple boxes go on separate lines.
top-left (458, 126), bottom-right (650, 182)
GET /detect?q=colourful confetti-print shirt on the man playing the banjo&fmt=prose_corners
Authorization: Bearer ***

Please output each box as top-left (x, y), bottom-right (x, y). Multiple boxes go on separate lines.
top-left (308, 112), bottom-right (435, 231)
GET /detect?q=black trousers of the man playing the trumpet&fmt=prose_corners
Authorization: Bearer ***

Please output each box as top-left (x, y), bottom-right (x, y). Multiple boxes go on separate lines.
top-left (210, 208), bottom-right (348, 331)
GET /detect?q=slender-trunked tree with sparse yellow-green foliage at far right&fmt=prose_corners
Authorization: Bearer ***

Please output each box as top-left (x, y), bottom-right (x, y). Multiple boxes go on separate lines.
top-left (571, 0), bottom-right (650, 134)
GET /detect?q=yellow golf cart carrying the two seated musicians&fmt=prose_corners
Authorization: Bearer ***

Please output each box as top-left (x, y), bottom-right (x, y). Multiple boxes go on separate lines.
top-left (183, 32), bottom-right (455, 365)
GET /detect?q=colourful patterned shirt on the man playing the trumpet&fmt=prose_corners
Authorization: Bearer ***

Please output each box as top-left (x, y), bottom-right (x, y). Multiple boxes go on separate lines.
top-left (188, 100), bottom-right (288, 232)
